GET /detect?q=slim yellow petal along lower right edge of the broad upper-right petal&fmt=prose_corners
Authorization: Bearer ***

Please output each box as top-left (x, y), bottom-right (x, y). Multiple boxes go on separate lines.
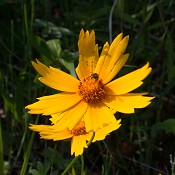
top-left (103, 54), bottom-right (129, 84)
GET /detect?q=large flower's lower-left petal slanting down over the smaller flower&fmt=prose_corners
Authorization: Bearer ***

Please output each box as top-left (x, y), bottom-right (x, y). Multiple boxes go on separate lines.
top-left (53, 101), bottom-right (88, 131)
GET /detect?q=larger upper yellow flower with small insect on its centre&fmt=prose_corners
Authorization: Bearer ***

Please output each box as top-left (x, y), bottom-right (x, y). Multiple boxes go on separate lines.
top-left (26, 30), bottom-right (154, 132)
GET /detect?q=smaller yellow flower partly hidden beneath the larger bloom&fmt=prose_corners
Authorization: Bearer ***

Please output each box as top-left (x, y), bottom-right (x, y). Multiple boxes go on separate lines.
top-left (29, 114), bottom-right (121, 156)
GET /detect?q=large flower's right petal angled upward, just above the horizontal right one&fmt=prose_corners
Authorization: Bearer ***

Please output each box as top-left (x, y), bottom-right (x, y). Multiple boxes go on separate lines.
top-left (106, 63), bottom-right (152, 95)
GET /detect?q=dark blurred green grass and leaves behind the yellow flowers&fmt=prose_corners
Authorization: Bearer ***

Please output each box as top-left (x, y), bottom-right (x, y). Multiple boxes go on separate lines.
top-left (0, 0), bottom-right (175, 175)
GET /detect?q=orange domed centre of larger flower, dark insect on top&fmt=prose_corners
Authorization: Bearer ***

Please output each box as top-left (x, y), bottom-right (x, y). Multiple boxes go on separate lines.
top-left (78, 73), bottom-right (106, 104)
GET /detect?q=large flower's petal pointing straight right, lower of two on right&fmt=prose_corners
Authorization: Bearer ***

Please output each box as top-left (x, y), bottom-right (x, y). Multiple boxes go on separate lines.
top-left (103, 93), bottom-right (154, 114)
